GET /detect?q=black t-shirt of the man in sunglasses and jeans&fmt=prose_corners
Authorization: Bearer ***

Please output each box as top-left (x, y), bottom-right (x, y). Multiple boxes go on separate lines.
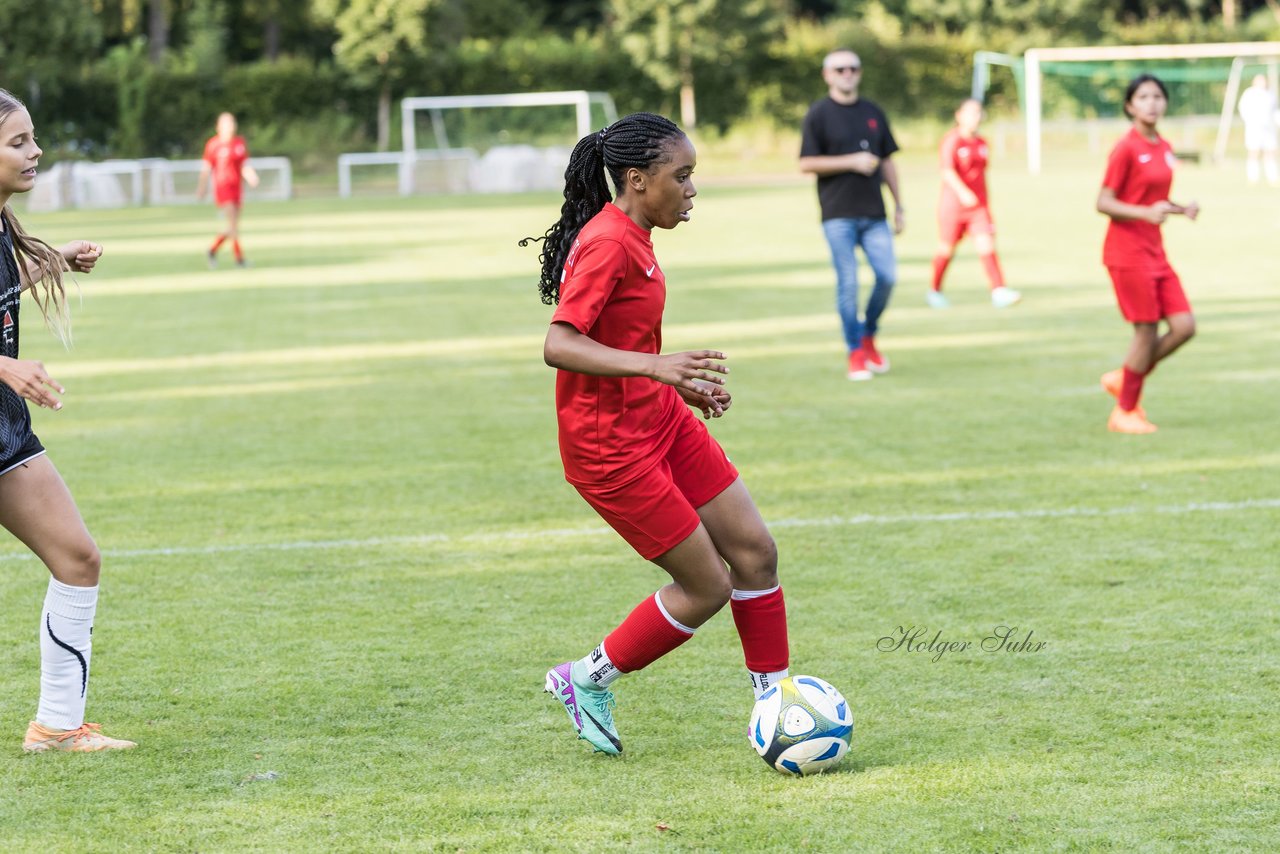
top-left (800, 96), bottom-right (897, 220)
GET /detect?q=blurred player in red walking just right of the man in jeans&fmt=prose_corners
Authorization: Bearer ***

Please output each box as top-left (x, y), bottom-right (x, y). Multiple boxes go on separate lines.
top-left (927, 97), bottom-right (1023, 309)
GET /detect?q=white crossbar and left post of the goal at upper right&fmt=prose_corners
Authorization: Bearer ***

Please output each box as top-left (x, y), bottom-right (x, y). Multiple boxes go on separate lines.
top-left (1023, 41), bottom-right (1280, 174)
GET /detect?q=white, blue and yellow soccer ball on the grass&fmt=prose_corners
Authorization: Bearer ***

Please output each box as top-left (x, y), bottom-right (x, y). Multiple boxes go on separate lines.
top-left (748, 676), bottom-right (854, 776)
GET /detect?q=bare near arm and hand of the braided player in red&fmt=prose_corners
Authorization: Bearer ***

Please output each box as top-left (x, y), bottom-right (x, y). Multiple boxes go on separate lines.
top-left (543, 321), bottom-right (728, 396)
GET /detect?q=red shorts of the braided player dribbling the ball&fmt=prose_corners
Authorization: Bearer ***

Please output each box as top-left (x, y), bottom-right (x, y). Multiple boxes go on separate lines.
top-left (575, 410), bottom-right (737, 561)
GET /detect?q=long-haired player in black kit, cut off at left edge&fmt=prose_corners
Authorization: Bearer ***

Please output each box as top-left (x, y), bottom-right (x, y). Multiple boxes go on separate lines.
top-left (0, 90), bottom-right (134, 752)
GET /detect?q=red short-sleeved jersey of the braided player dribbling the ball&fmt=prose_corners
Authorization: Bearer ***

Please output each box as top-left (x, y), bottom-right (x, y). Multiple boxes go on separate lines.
top-left (552, 204), bottom-right (690, 487)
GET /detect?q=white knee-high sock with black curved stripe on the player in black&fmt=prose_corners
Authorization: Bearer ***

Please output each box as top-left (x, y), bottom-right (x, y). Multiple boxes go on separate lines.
top-left (36, 579), bottom-right (97, 730)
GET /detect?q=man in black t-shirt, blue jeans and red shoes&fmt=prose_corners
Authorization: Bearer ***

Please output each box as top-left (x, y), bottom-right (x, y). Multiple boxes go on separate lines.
top-left (800, 49), bottom-right (904, 380)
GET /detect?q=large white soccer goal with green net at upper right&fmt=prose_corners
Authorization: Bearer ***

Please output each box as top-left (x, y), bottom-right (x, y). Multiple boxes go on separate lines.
top-left (973, 42), bottom-right (1280, 173)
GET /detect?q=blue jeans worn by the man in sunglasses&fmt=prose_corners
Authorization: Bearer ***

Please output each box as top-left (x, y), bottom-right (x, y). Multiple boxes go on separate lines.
top-left (822, 216), bottom-right (897, 352)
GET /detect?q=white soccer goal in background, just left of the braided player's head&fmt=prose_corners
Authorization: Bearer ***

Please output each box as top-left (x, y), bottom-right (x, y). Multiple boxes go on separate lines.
top-left (397, 91), bottom-right (618, 195)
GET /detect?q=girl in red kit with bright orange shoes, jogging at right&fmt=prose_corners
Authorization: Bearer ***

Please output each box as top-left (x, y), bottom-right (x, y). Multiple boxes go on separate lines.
top-left (1098, 74), bottom-right (1199, 433)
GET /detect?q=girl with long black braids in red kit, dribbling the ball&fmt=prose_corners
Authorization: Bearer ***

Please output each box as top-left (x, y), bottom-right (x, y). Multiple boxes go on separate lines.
top-left (521, 113), bottom-right (788, 754)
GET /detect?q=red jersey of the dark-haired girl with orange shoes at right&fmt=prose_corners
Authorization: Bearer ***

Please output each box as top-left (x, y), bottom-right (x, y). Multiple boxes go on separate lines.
top-left (1102, 129), bottom-right (1178, 268)
